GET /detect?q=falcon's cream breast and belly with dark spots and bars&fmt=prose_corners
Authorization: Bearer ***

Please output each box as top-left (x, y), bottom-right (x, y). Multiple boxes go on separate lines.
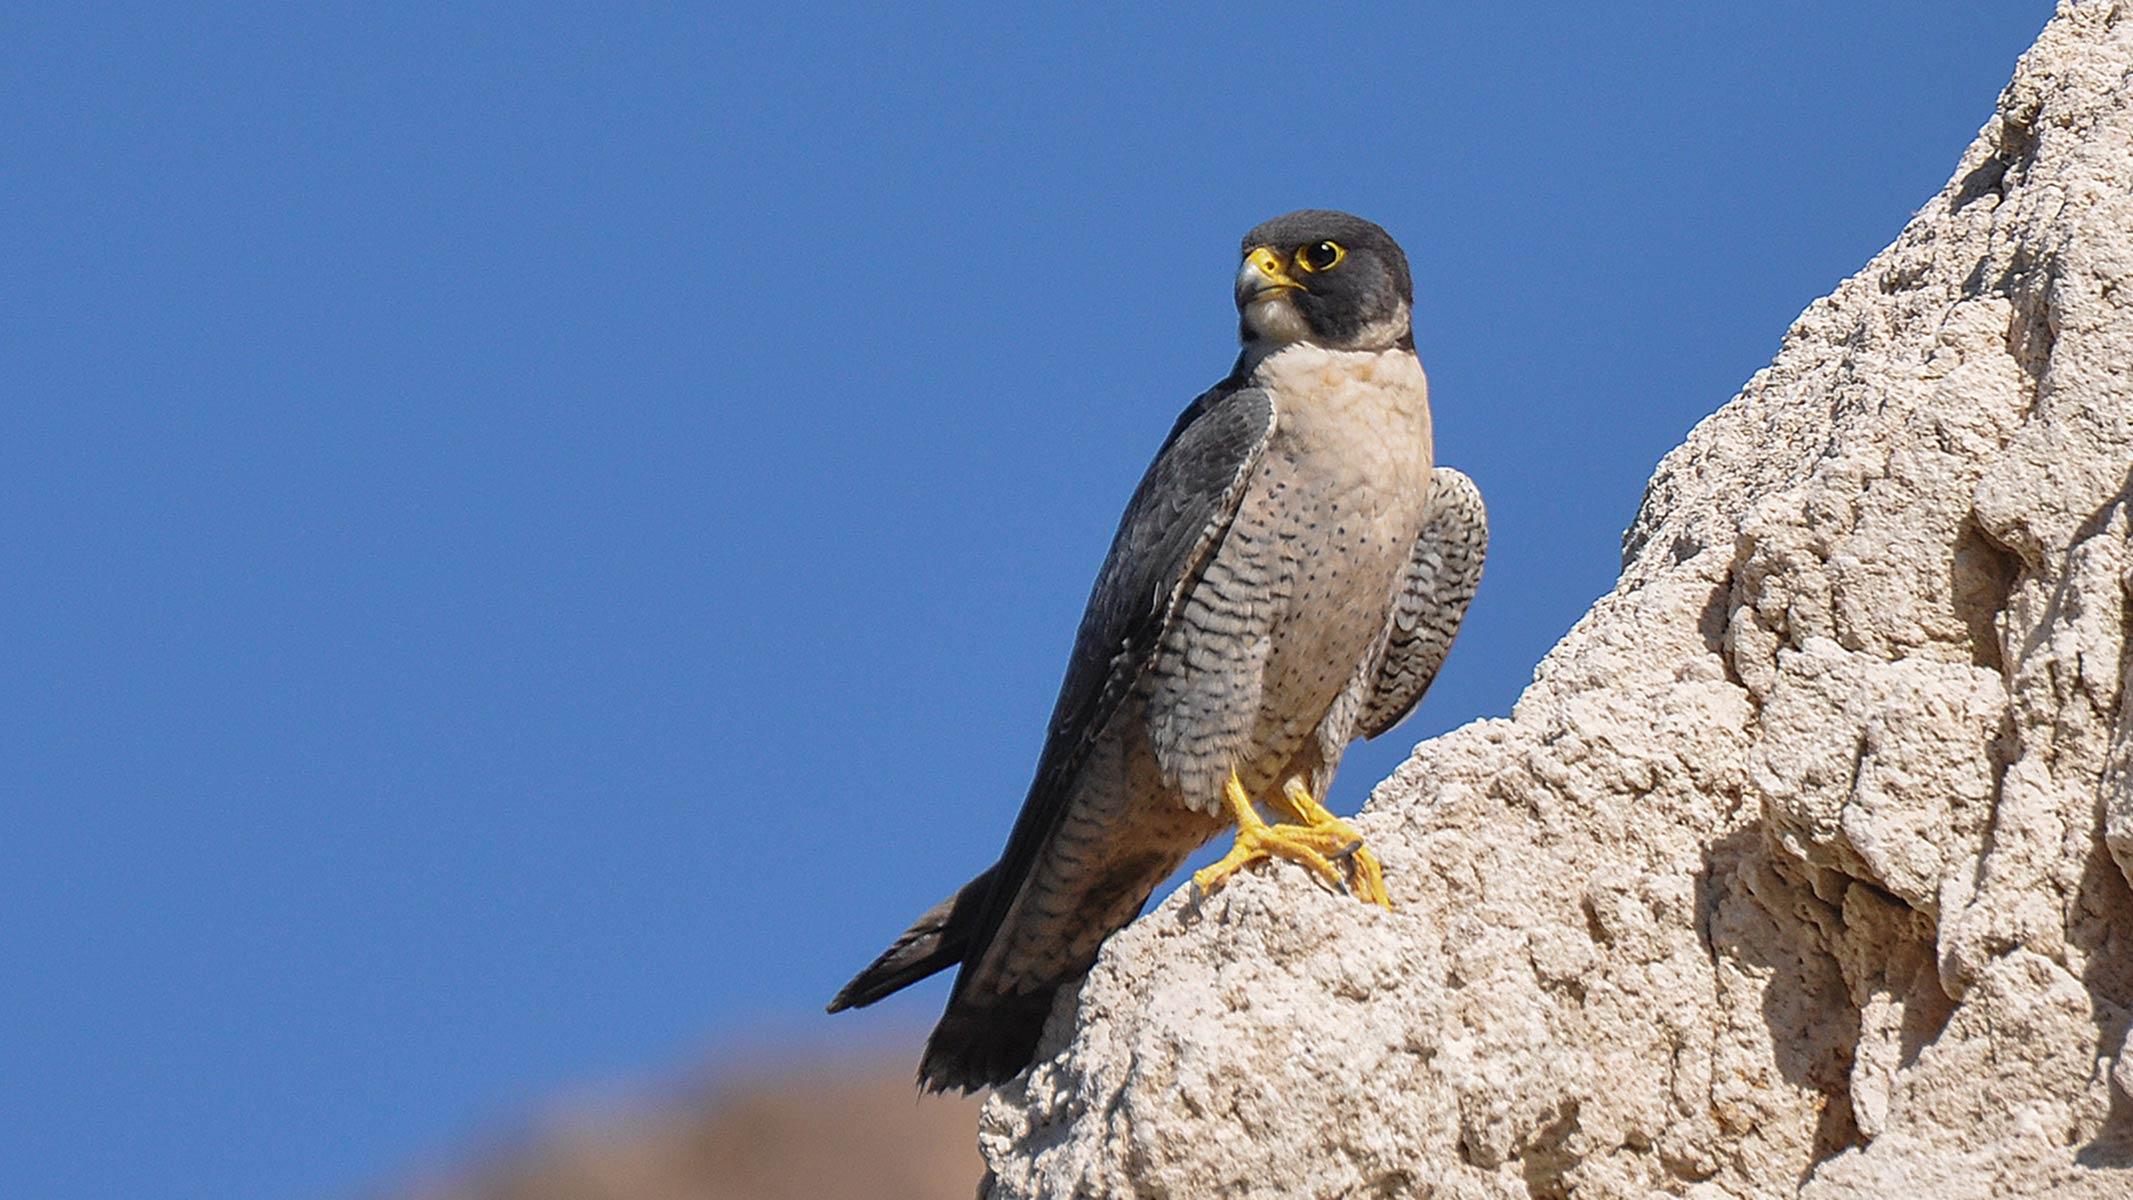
top-left (1143, 345), bottom-right (1431, 812)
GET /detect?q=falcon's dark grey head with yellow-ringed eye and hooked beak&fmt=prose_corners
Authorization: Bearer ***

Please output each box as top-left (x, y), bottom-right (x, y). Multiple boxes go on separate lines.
top-left (1237, 209), bottom-right (1414, 350)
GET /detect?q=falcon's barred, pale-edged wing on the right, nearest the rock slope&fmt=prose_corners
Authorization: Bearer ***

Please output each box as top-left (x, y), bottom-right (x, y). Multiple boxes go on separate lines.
top-left (1357, 467), bottom-right (1489, 737)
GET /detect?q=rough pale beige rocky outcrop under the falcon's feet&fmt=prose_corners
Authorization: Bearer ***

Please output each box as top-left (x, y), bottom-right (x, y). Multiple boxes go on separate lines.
top-left (981, 0), bottom-right (2133, 1200)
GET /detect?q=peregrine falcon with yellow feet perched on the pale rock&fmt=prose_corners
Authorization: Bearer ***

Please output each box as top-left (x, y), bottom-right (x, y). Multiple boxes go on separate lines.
top-left (830, 209), bottom-right (1489, 1091)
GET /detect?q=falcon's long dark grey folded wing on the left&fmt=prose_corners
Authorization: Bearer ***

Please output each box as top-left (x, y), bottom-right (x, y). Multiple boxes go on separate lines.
top-left (958, 386), bottom-right (1273, 976)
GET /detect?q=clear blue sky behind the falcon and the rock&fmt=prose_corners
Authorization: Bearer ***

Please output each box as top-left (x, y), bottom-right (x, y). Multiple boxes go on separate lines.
top-left (0, 0), bottom-right (2050, 1200)
